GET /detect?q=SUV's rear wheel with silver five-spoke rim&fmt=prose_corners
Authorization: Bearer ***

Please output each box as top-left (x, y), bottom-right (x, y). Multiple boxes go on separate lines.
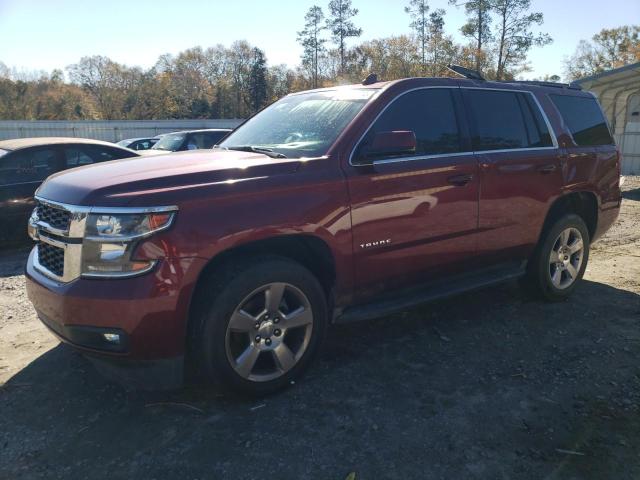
top-left (524, 214), bottom-right (590, 302)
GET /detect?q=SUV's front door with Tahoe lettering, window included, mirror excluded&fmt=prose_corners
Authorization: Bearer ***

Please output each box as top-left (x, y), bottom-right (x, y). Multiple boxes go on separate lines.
top-left (347, 88), bottom-right (479, 300)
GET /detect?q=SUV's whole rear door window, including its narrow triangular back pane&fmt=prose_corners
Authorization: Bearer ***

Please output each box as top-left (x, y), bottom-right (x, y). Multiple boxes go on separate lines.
top-left (465, 90), bottom-right (553, 151)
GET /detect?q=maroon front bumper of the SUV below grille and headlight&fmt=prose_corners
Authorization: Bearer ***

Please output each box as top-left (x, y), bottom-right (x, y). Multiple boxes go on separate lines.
top-left (25, 251), bottom-right (205, 386)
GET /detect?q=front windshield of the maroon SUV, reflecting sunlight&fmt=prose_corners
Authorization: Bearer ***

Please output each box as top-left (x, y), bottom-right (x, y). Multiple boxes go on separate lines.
top-left (220, 88), bottom-right (377, 158)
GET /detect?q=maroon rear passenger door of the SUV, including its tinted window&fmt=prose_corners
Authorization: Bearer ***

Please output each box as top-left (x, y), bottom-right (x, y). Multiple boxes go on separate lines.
top-left (462, 88), bottom-right (562, 263)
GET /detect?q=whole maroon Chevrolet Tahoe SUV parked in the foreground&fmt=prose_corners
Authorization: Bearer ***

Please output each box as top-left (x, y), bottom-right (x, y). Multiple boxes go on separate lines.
top-left (26, 73), bottom-right (621, 394)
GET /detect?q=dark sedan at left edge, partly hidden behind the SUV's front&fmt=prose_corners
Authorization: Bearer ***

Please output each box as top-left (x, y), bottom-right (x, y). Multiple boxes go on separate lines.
top-left (0, 137), bottom-right (140, 248)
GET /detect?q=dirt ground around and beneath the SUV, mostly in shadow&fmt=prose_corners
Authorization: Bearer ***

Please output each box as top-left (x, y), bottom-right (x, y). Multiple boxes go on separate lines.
top-left (0, 177), bottom-right (640, 480)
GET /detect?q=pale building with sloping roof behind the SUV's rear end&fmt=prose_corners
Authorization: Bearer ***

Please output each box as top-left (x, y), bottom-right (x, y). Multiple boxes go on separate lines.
top-left (574, 62), bottom-right (640, 175)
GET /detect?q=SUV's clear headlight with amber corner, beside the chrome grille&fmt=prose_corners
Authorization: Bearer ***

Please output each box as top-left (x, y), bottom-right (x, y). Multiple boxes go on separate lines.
top-left (81, 211), bottom-right (175, 277)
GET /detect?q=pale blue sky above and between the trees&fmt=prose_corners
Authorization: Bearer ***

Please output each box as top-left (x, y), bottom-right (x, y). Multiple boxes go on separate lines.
top-left (0, 0), bottom-right (640, 78)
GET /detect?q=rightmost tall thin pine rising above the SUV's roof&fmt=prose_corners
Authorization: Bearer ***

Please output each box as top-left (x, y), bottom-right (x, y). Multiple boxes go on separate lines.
top-left (493, 0), bottom-right (552, 80)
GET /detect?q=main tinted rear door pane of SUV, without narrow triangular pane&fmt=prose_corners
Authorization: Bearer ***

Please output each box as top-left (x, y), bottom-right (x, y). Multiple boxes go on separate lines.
top-left (465, 89), bottom-right (535, 151)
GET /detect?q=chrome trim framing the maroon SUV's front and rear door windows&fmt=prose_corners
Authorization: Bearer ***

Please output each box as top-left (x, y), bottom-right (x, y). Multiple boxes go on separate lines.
top-left (349, 85), bottom-right (559, 167)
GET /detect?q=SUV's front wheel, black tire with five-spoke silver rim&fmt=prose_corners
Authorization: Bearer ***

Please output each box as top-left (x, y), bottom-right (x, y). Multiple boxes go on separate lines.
top-left (191, 257), bottom-right (328, 396)
